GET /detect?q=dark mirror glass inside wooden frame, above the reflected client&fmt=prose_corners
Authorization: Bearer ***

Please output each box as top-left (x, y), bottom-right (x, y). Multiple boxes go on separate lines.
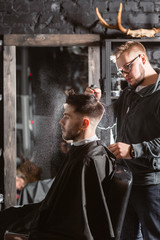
top-left (16, 46), bottom-right (88, 179)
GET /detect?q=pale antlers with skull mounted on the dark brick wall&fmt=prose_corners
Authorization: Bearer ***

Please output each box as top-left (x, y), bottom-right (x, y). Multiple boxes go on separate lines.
top-left (96, 3), bottom-right (160, 38)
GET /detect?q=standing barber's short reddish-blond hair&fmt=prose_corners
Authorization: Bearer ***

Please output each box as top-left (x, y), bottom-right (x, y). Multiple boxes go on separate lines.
top-left (113, 41), bottom-right (147, 59)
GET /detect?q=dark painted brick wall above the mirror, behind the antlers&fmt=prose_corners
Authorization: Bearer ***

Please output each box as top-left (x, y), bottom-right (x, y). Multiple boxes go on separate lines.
top-left (0, 0), bottom-right (160, 37)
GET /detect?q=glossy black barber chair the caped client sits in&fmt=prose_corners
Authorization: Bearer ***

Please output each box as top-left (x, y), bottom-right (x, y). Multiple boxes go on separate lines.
top-left (4, 164), bottom-right (132, 240)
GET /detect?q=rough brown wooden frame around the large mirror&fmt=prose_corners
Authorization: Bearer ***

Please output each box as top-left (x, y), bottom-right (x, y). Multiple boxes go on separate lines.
top-left (3, 34), bottom-right (100, 208)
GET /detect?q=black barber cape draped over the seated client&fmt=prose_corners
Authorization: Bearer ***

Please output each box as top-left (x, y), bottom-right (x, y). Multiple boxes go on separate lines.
top-left (3, 140), bottom-right (115, 240)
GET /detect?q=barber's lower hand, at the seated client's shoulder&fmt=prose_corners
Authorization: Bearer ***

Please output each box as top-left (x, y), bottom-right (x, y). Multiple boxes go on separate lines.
top-left (108, 142), bottom-right (131, 160)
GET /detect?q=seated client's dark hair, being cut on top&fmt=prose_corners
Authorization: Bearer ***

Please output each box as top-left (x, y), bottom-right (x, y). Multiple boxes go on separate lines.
top-left (66, 90), bottom-right (104, 119)
